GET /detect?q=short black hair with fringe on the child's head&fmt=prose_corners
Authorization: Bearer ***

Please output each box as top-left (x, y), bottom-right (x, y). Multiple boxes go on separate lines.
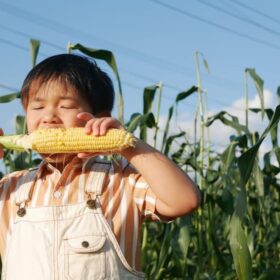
top-left (21, 54), bottom-right (115, 114)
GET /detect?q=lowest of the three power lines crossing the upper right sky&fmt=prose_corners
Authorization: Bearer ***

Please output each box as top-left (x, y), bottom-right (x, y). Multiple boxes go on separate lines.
top-left (149, 0), bottom-right (280, 50)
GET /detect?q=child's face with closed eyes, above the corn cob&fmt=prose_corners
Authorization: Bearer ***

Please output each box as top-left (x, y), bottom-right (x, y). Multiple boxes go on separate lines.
top-left (26, 77), bottom-right (91, 133)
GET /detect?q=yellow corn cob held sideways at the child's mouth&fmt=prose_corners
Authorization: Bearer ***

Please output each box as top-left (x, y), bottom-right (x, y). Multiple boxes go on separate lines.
top-left (0, 127), bottom-right (134, 154)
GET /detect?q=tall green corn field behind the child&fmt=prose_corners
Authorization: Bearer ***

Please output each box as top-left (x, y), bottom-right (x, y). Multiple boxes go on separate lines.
top-left (0, 40), bottom-right (280, 280)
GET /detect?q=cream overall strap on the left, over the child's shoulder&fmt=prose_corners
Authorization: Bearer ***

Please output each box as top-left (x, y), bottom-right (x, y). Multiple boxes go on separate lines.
top-left (15, 168), bottom-right (38, 206)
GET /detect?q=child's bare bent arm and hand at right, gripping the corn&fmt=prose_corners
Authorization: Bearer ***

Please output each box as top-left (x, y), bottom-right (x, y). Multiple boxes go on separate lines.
top-left (78, 113), bottom-right (200, 217)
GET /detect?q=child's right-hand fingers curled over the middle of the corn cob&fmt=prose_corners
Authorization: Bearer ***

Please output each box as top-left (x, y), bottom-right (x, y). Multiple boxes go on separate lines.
top-left (77, 112), bottom-right (123, 158)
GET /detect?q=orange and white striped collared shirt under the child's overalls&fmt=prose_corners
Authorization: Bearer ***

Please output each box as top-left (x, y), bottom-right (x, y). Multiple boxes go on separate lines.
top-left (0, 158), bottom-right (159, 270)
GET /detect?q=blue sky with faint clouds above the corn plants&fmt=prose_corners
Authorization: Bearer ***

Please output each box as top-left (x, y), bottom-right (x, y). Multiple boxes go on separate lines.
top-left (0, 0), bottom-right (280, 152)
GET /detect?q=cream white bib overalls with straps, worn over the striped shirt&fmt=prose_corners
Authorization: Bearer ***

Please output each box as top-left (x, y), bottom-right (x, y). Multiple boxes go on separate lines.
top-left (2, 163), bottom-right (144, 280)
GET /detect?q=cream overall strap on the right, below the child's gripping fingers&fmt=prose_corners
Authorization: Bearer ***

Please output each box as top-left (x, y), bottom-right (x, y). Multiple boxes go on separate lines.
top-left (85, 161), bottom-right (111, 198)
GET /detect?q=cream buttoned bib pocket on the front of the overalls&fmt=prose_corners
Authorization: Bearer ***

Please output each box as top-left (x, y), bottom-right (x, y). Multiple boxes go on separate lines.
top-left (64, 234), bottom-right (106, 280)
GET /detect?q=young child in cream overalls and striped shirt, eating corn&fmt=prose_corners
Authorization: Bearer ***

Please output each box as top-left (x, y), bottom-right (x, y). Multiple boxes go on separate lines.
top-left (0, 54), bottom-right (200, 280)
